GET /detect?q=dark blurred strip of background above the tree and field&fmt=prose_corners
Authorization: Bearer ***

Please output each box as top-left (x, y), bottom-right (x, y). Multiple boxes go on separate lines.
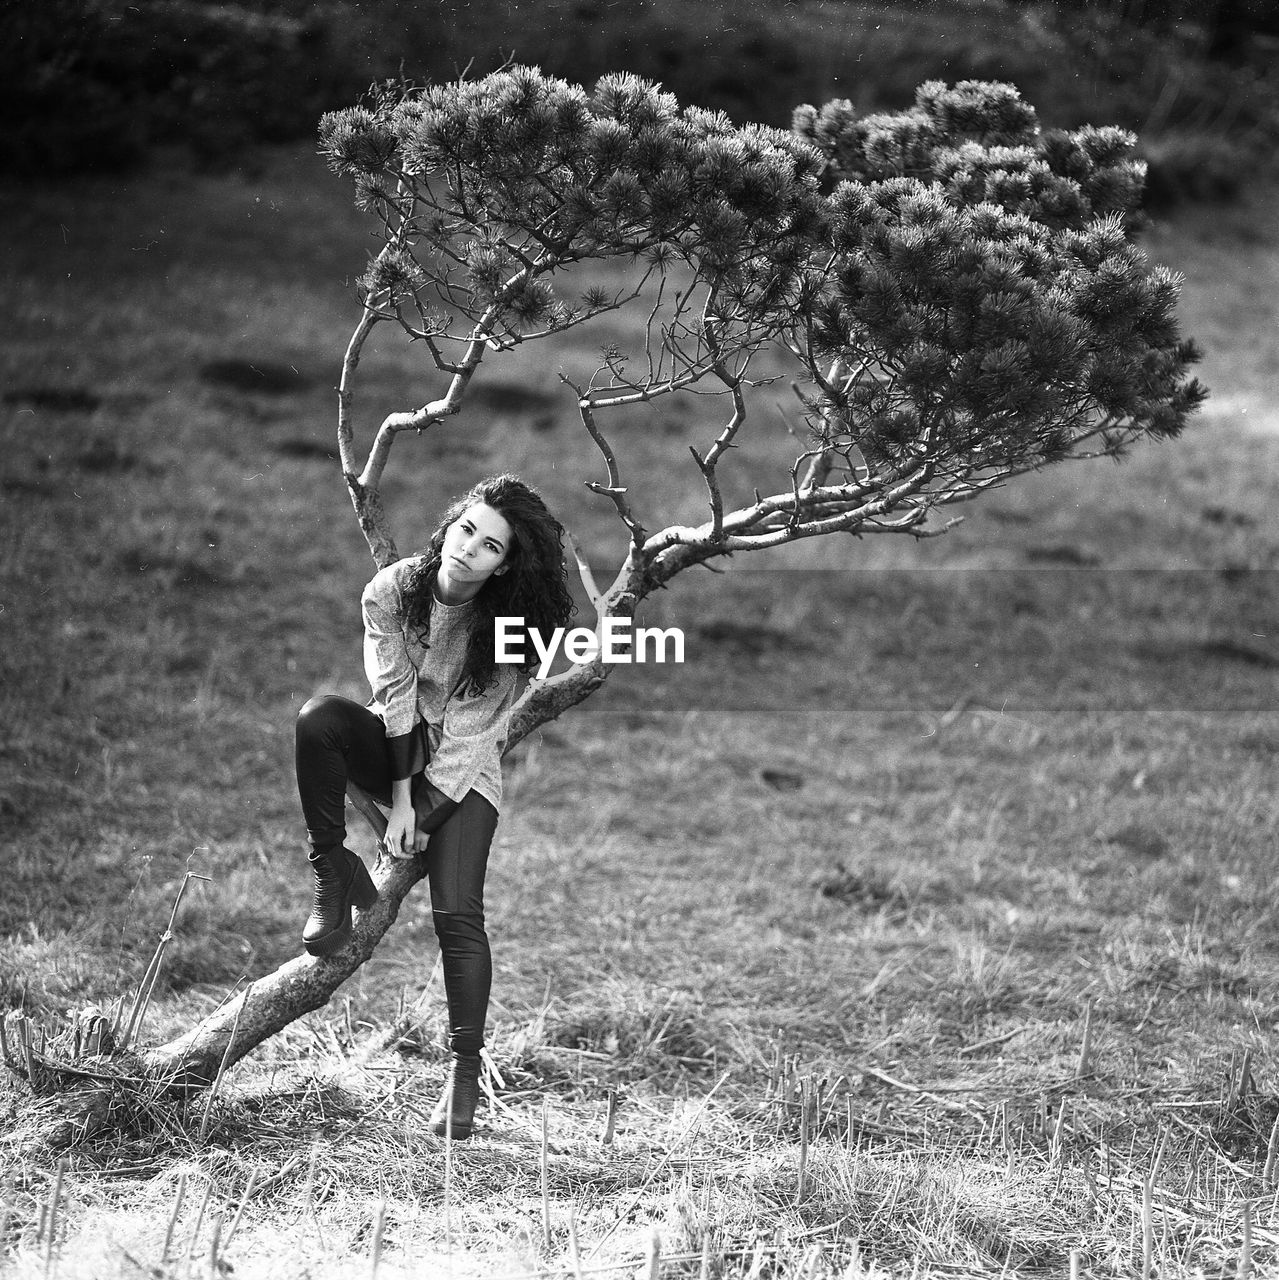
top-left (0, 0), bottom-right (1279, 205)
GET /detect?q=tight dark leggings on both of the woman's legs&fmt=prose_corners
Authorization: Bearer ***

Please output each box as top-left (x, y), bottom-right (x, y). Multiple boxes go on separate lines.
top-left (294, 694), bottom-right (497, 1053)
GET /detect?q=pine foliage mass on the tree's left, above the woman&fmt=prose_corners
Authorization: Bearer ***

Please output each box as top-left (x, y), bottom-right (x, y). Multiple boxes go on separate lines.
top-left (320, 67), bottom-right (822, 353)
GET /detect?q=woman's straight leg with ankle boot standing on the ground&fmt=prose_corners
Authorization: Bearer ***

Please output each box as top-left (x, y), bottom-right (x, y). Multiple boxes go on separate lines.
top-left (426, 791), bottom-right (497, 1138)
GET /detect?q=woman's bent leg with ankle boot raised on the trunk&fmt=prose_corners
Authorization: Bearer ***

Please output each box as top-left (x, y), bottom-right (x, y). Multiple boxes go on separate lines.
top-left (294, 694), bottom-right (390, 956)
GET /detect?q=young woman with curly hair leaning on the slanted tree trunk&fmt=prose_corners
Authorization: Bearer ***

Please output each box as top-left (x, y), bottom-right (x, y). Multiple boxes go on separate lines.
top-left (296, 475), bottom-right (574, 1138)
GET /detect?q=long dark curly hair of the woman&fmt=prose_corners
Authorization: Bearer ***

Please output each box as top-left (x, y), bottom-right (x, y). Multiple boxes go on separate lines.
top-left (405, 475), bottom-right (576, 695)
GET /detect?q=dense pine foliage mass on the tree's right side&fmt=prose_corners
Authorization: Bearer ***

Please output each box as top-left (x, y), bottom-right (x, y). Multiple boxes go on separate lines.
top-left (794, 82), bottom-right (1203, 497)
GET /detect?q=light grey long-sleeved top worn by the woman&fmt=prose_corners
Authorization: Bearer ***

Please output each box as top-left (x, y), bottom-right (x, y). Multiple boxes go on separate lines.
top-left (361, 557), bottom-right (516, 809)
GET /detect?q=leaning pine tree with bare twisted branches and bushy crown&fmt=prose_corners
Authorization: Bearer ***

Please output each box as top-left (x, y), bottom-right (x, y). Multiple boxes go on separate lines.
top-left (5, 68), bottom-right (1203, 1111)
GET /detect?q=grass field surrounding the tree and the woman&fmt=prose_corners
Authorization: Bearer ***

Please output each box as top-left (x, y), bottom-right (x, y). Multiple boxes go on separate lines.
top-left (0, 127), bottom-right (1279, 1280)
